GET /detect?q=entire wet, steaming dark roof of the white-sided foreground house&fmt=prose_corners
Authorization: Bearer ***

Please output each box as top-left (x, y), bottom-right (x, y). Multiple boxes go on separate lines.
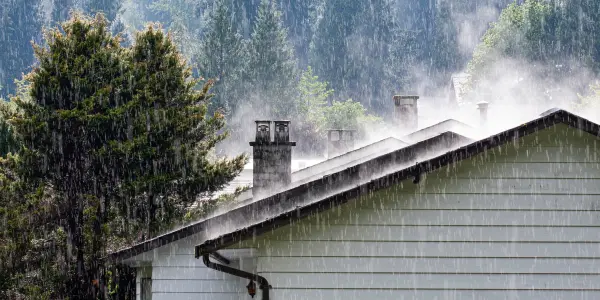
top-left (108, 110), bottom-right (599, 260)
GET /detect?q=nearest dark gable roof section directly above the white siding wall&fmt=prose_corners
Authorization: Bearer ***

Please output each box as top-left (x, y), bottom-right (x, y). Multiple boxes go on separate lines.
top-left (195, 110), bottom-right (600, 257)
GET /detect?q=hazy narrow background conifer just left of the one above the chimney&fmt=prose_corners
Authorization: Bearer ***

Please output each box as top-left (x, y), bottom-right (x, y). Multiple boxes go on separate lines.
top-left (198, 0), bottom-right (246, 115)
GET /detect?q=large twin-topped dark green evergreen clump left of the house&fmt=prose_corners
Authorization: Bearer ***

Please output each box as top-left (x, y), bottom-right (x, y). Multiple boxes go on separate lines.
top-left (2, 15), bottom-right (245, 299)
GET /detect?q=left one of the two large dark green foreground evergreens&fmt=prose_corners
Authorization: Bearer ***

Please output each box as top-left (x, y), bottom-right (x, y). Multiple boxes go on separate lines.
top-left (13, 16), bottom-right (129, 299)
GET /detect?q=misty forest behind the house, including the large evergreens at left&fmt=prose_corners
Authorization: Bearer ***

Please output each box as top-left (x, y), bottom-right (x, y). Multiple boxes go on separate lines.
top-left (0, 0), bottom-right (600, 299)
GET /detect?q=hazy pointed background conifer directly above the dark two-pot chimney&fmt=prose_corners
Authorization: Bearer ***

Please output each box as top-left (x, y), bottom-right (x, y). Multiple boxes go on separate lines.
top-left (246, 0), bottom-right (298, 118)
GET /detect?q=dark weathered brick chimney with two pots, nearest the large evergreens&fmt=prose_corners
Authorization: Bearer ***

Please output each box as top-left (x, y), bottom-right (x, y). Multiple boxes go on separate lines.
top-left (250, 121), bottom-right (296, 198)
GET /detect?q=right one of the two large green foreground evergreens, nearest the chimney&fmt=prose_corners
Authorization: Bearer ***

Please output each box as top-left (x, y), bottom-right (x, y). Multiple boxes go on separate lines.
top-left (123, 27), bottom-right (246, 236)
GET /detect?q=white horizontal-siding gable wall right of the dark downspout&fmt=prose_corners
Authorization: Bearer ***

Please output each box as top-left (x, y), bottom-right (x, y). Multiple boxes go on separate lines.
top-left (231, 125), bottom-right (600, 300)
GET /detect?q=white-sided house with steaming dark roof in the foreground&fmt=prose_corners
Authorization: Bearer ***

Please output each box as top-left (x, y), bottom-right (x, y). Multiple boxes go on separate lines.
top-left (109, 96), bottom-right (600, 300)
